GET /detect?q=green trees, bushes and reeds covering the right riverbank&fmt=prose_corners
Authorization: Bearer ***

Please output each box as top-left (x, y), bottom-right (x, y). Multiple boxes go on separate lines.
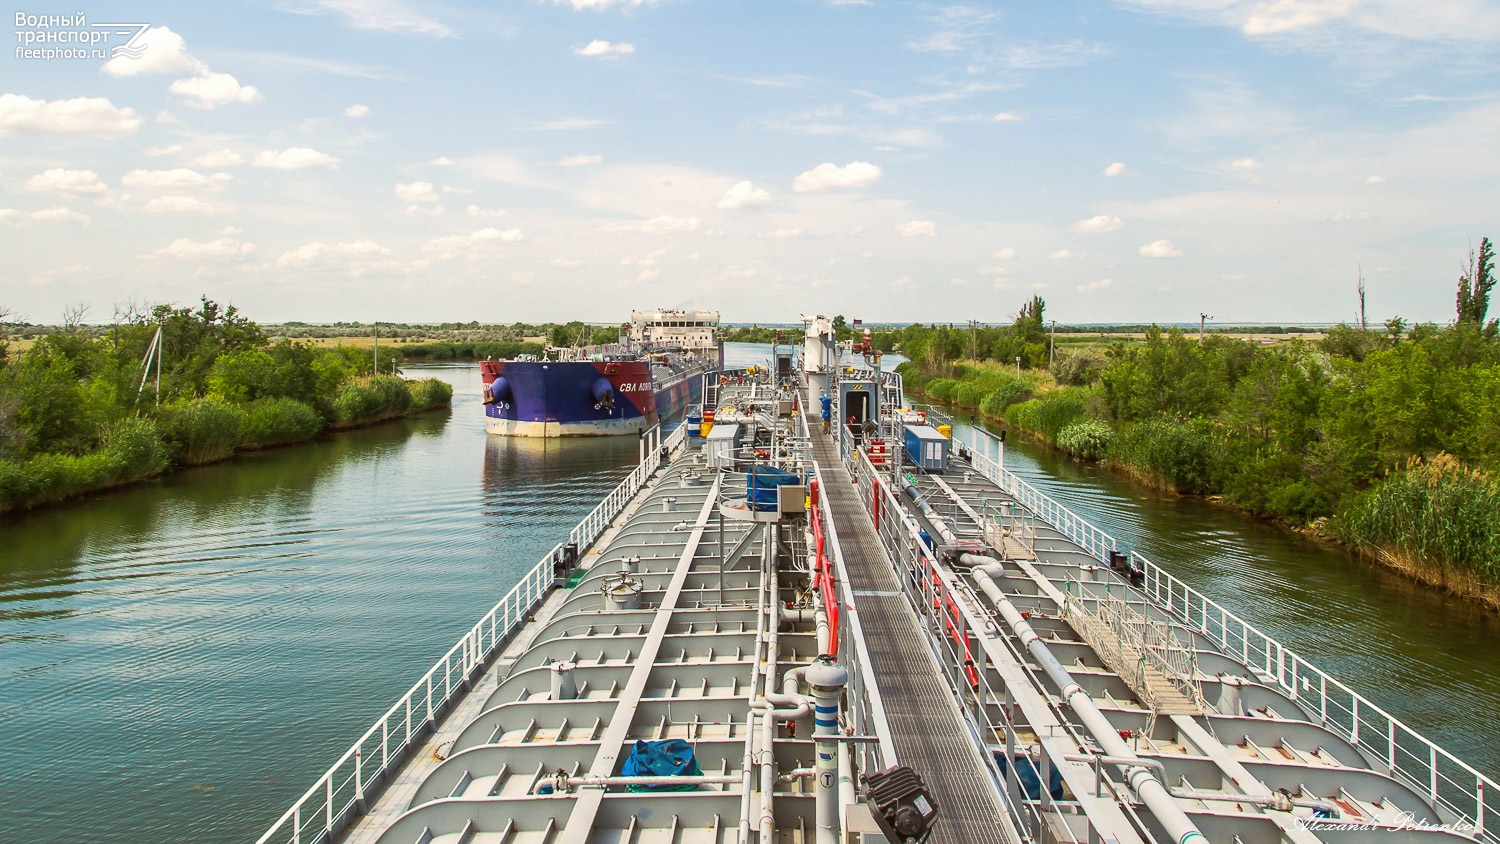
top-left (884, 240), bottom-right (1500, 601)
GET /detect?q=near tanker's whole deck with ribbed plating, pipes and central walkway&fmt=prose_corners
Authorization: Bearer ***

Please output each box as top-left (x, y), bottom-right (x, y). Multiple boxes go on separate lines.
top-left (261, 350), bottom-right (1500, 844)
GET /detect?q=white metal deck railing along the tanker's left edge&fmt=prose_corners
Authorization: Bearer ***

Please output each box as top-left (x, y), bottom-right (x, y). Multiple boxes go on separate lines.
top-left (257, 426), bottom-right (687, 844)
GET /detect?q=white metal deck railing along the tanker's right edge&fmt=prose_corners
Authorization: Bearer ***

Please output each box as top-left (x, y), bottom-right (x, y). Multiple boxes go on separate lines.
top-left (954, 429), bottom-right (1500, 843)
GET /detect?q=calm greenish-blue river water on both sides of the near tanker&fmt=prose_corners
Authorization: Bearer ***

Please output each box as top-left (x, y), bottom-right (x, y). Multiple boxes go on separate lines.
top-left (0, 352), bottom-right (1500, 844)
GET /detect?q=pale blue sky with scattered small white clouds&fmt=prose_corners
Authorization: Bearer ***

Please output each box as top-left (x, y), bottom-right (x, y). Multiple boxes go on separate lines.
top-left (0, 0), bottom-right (1500, 324)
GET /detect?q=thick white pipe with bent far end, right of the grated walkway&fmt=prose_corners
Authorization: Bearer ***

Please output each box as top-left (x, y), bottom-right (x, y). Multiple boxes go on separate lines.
top-left (963, 555), bottom-right (1208, 844)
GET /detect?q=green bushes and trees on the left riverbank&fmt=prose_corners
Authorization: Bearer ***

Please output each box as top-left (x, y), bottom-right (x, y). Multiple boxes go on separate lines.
top-left (0, 298), bottom-right (453, 511)
